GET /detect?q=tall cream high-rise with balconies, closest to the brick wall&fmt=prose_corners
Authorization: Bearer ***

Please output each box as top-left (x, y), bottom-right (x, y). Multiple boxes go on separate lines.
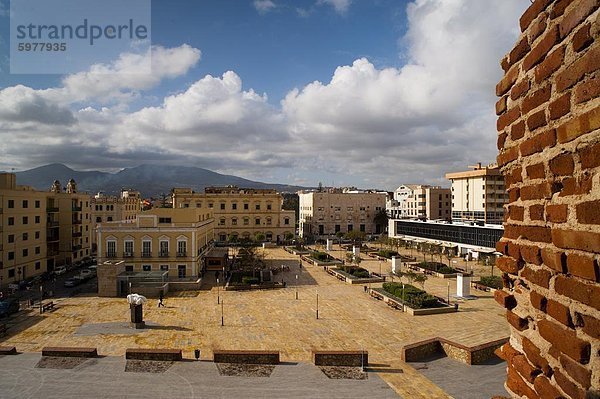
top-left (446, 163), bottom-right (508, 224)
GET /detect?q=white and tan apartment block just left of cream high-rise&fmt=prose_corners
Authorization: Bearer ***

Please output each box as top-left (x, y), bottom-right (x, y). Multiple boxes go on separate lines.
top-left (386, 184), bottom-right (451, 220)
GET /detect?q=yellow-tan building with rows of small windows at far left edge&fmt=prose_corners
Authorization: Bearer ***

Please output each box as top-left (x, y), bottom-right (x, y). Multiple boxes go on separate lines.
top-left (0, 173), bottom-right (52, 291)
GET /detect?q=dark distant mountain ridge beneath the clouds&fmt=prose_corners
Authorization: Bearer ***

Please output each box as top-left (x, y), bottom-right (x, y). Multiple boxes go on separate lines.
top-left (11, 163), bottom-right (306, 197)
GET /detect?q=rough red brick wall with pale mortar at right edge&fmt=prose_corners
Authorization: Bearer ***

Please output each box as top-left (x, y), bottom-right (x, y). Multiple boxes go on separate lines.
top-left (496, 0), bottom-right (600, 399)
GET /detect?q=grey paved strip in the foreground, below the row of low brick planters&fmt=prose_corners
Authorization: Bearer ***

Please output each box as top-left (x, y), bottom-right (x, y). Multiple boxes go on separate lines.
top-left (0, 353), bottom-right (398, 399)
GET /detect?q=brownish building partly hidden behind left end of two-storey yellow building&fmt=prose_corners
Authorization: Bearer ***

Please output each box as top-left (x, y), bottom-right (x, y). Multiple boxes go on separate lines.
top-left (92, 190), bottom-right (142, 253)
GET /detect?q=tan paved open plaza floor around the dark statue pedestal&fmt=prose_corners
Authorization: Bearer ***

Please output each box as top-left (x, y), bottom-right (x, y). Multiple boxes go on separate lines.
top-left (0, 248), bottom-right (508, 398)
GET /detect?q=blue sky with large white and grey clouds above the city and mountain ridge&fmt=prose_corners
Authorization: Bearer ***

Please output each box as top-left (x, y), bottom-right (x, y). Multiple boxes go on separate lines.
top-left (0, 0), bottom-right (529, 189)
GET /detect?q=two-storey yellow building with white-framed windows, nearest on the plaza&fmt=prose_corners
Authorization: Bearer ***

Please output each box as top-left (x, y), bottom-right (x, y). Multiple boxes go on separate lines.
top-left (97, 208), bottom-right (214, 296)
